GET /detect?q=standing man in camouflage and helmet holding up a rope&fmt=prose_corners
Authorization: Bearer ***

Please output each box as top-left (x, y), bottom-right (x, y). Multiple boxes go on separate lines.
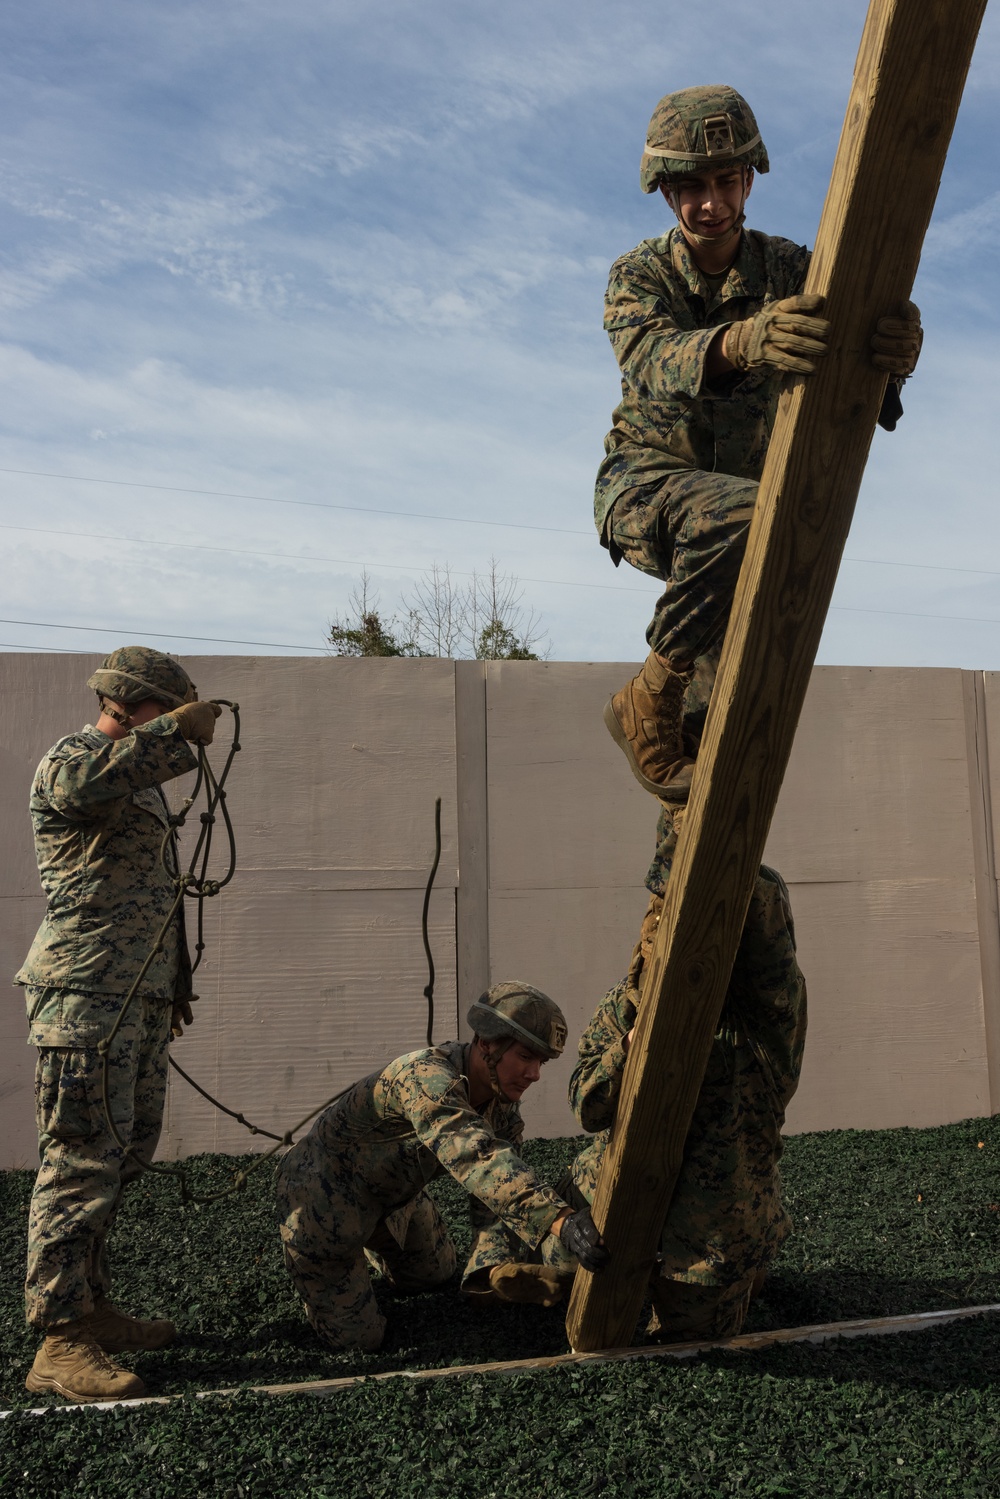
top-left (13, 646), bottom-right (222, 1400)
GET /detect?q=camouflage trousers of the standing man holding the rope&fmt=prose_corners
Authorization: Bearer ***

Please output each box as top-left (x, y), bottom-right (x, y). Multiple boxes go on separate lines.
top-left (24, 988), bottom-right (171, 1328)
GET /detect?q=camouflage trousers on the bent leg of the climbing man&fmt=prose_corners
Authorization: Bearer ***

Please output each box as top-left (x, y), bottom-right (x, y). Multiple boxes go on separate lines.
top-left (610, 469), bottom-right (757, 669)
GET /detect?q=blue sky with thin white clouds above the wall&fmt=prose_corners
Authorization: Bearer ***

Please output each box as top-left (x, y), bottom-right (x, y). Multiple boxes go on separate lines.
top-left (0, 0), bottom-right (1000, 669)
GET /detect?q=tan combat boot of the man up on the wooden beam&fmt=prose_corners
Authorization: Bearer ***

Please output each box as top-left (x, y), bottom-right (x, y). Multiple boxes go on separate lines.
top-left (604, 651), bottom-right (694, 799)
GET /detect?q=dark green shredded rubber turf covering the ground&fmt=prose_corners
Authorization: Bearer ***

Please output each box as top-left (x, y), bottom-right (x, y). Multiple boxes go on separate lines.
top-left (0, 1120), bottom-right (1000, 1499)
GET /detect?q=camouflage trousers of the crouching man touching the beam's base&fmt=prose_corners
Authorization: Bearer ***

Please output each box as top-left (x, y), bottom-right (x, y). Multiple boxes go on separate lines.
top-left (277, 1135), bottom-right (456, 1352)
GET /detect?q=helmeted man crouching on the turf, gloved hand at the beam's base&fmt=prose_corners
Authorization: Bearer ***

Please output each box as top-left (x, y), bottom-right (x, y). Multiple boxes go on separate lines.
top-left (277, 982), bottom-right (607, 1351)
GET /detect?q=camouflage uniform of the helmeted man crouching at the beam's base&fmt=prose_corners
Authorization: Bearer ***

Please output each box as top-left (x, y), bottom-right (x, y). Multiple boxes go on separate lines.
top-left (277, 1042), bottom-right (565, 1349)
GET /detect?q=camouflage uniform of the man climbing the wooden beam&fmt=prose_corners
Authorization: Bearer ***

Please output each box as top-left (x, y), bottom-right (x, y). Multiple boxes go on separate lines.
top-left (594, 228), bottom-right (808, 701)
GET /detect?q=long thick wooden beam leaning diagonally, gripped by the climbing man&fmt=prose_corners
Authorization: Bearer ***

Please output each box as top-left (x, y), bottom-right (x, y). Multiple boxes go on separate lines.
top-left (567, 0), bottom-right (985, 1352)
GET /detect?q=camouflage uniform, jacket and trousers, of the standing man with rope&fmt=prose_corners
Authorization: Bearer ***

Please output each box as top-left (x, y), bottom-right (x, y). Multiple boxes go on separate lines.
top-left (13, 715), bottom-right (196, 1328)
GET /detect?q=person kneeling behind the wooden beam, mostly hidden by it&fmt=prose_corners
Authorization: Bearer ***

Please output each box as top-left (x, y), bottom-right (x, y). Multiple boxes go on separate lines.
top-left (466, 863), bottom-right (807, 1343)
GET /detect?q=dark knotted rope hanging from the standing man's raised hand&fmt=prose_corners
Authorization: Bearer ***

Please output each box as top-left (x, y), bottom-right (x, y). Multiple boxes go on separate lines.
top-left (97, 697), bottom-right (441, 1205)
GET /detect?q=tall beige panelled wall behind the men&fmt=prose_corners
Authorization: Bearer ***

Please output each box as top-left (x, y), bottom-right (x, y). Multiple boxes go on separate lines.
top-left (0, 654), bottom-right (1000, 1165)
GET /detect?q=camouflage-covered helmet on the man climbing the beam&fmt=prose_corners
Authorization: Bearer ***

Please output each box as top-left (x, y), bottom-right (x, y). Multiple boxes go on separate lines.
top-left (640, 84), bottom-right (769, 192)
